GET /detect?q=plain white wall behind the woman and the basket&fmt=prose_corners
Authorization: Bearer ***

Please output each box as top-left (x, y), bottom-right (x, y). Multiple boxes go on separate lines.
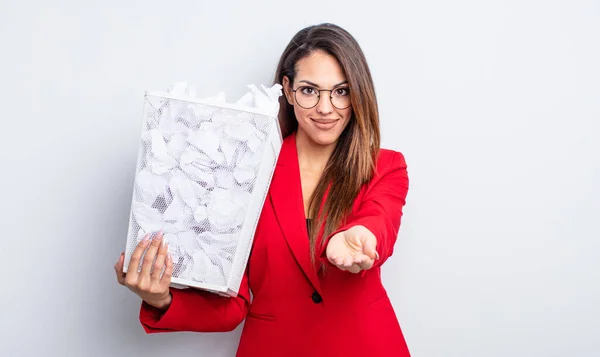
top-left (0, 0), bottom-right (600, 357)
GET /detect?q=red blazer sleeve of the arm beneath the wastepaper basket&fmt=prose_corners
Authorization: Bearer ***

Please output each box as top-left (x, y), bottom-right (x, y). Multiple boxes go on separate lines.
top-left (139, 269), bottom-right (250, 333)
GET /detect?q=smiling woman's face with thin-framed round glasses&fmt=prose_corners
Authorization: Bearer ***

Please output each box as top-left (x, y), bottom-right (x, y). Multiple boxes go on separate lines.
top-left (283, 51), bottom-right (352, 146)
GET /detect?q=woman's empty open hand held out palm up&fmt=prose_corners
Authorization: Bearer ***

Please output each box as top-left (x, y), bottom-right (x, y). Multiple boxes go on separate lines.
top-left (327, 226), bottom-right (379, 273)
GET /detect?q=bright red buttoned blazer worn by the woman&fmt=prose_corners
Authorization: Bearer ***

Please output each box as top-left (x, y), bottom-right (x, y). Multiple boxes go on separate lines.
top-left (140, 134), bottom-right (410, 357)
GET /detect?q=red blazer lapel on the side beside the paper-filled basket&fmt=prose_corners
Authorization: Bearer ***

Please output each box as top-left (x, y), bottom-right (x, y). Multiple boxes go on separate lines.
top-left (269, 134), bottom-right (322, 294)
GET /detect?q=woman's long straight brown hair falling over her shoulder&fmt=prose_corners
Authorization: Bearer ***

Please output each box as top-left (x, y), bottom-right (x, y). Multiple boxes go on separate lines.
top-left (275, 24), bottom-right (380, 261)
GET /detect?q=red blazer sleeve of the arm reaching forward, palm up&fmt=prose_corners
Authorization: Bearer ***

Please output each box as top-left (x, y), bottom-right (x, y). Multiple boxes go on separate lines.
top-left (320, 152), bottom-right (408, 267)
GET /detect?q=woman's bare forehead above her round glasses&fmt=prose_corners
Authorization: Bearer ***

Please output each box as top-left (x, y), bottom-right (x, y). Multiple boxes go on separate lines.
top-left (296, 51), bottom-right (346, 88)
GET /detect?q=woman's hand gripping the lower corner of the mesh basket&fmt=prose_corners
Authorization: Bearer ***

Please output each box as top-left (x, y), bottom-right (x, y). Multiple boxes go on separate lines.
top-left (115, 231), bottom-right (173, 310)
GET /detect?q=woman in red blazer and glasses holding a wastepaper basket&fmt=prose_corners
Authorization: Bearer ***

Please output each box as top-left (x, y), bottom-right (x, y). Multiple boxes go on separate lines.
top-left (115, 24), bottom-right (409, 357)
